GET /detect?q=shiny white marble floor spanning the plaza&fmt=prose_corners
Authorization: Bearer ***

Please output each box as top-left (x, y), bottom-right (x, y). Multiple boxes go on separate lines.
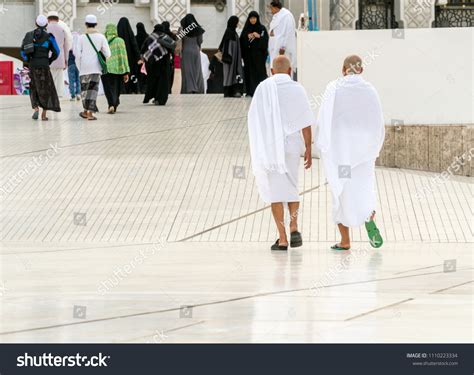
top-left (0, 95), bottom-right (473, 343)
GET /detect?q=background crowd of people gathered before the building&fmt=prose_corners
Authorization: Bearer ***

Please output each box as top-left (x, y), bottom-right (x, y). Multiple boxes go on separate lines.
top-left (21, 1), bottom-right (295, 120)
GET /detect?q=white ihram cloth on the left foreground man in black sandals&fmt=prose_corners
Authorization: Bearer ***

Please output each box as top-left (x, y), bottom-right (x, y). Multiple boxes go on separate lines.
top-left (248, 74), bottom-right (315, 203)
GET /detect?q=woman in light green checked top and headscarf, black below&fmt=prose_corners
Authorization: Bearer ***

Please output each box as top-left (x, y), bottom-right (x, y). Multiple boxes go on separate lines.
top-left (101, 23), bottom-right (130, 114)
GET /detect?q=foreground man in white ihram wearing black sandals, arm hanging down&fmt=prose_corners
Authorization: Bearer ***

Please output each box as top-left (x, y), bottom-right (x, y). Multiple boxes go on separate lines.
top-left (248, 56), bottom-right (315, 250)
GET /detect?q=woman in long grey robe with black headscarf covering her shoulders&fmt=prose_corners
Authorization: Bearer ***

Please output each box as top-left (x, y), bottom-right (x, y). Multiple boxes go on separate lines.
top-left (178, 14), bottom-right (205, 94)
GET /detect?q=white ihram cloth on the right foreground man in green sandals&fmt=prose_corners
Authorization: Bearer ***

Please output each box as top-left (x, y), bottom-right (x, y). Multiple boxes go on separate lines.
top-left (317, 75), bottom-right (385, 227)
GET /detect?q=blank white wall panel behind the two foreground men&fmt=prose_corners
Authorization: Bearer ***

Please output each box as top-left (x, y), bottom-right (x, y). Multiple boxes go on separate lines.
top-left (298, 28), bottom-right (474, 125)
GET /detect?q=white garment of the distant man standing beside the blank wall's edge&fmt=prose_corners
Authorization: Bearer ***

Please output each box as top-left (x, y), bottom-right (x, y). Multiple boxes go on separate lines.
top-left (268, 8), bottom-right (296, 70)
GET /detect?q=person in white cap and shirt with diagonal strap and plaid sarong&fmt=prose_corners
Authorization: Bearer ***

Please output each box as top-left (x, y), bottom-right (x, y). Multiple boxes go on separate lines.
top-left (74, 14), bottom-right (110, 120)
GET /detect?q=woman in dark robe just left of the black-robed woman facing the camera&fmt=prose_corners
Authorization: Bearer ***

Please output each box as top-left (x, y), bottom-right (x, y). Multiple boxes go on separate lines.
top-left (219, 16), bottom-right (243, 98)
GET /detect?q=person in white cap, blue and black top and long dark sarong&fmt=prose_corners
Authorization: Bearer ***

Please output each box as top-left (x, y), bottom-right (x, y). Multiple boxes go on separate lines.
top-left (21, 14), bottom-right (61, 121)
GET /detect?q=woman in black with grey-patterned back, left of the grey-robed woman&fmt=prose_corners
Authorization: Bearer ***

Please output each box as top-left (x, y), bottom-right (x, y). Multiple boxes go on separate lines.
top-left (142, 24), bottom-right (176, 105)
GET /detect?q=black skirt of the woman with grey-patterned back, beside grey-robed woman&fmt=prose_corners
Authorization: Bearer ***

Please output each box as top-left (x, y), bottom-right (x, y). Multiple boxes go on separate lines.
top-left (143, 54), bottom-right (170, 105)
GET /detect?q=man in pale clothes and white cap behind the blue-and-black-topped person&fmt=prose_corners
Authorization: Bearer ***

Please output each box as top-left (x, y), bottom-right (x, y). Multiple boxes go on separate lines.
top-left (48, 11), bottom-right (72, 97)
